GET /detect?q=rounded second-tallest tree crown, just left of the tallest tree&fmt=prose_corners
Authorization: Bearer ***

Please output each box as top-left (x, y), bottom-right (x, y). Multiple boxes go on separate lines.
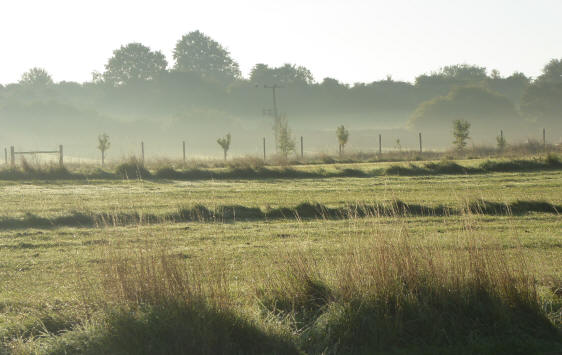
top-left (103, 43), bottom-right (168, 86)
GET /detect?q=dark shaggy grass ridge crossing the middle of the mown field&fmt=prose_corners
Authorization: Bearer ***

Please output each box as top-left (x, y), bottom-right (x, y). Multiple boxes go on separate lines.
top-left (0, 200), bottom-right (562, 229)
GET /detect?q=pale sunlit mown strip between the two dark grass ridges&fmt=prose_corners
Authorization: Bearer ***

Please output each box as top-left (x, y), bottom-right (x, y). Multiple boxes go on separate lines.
top-left (0, 171), bottom-right (562, 219)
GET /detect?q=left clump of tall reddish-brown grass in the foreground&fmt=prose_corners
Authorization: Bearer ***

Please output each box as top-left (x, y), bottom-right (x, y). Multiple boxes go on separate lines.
top-left (44, 245), bottom-right (298, 354)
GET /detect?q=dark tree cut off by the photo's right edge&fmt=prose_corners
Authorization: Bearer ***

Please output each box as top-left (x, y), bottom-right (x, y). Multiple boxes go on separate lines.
top-left (521, 59), bottom-right (562, 127)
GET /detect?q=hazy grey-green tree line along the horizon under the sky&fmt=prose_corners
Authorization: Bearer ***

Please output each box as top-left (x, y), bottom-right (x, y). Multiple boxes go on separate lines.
top-left (0, 31), bottom-right (562, 154)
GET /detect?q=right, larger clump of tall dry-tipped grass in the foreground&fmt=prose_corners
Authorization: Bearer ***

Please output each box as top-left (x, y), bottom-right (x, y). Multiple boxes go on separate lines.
top-left (257, 222), bottom-right (560, 354)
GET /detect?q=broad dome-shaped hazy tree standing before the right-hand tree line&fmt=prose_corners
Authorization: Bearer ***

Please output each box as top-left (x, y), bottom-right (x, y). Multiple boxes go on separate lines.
top-left (410, 86), bottom-right (519, 128)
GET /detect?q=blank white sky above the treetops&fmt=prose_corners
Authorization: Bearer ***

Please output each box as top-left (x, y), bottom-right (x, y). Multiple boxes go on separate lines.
top-left (0, 0), bottom-right (562, 84)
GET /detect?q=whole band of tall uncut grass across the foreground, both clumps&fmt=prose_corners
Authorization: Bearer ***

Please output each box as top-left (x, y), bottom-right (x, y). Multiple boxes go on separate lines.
top-left (3, 221), bottom-right (562, 354)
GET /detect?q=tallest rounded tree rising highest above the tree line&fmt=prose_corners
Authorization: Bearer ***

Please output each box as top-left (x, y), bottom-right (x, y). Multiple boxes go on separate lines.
top-left (174, 31), bottom-right (240, 79)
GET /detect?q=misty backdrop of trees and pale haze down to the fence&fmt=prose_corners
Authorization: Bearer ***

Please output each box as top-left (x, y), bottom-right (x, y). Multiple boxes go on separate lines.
top-left (0, 36), bottom-right (562, 159)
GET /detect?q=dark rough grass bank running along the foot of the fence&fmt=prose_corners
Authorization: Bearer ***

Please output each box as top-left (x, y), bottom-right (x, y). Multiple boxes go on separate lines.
top-left (0, 154), bottom-right (562, 180)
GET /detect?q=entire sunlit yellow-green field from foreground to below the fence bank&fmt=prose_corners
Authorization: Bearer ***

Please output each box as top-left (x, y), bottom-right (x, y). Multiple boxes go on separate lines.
top-left (0, 162), bottom-right (562, 354)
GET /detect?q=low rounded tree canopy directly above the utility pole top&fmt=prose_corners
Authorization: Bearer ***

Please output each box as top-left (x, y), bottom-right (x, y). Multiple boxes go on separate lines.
top-left (250, 63), bottom-right (314, 86)
